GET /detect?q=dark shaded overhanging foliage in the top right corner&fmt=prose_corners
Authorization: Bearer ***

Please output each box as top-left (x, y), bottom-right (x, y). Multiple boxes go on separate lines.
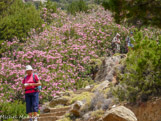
top-left (102, 0), bottom-right (161, 27)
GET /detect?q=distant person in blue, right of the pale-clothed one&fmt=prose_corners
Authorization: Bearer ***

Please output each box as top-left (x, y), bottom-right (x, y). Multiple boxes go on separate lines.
top-left (126, 32), bottom-right (135, 52)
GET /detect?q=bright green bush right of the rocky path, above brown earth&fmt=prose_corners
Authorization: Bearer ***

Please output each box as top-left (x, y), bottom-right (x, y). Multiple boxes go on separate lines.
top-left (114, 32), bottom-right (161, 102)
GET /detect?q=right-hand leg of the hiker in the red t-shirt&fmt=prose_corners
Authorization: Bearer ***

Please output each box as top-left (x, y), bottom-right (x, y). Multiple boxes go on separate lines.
top-left (32, 92), bottom-right (39, 120)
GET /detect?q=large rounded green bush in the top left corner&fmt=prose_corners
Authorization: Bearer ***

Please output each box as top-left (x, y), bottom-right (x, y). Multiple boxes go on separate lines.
top-left (0, 0), bottom-right (42, 41)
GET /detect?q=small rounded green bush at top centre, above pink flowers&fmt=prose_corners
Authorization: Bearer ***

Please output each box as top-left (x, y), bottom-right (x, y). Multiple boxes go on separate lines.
top-left (67, 0), bottom-right (88, 15)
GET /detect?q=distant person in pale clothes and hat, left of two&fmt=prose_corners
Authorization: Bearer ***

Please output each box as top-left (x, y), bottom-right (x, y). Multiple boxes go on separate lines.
top-left (112, 33), bottom-right (121, 53)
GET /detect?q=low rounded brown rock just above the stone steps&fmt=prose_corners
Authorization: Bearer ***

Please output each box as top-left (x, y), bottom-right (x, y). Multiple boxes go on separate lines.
top-left (49, 97), bottom-right (69, 107)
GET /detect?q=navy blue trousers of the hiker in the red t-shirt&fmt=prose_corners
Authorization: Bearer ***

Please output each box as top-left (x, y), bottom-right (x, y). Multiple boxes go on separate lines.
top-left (25, 92), bottom-right (39, 114)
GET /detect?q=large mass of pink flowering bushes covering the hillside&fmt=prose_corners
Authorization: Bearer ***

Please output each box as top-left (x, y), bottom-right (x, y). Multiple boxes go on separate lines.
top-left (0, 8), bottom-right (160, 102)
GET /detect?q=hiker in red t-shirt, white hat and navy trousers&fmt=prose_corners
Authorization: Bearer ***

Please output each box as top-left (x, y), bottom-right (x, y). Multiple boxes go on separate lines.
top-left (22, 65), bottom-right (41, 121)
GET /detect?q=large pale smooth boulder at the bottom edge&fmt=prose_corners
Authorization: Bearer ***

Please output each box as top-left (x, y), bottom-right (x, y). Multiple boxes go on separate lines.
top-left (103, 106), bottom-right (137, 121)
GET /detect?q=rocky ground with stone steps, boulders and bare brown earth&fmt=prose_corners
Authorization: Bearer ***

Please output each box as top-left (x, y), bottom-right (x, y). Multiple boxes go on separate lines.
top-left (23, 55), bottom-right (161, 121)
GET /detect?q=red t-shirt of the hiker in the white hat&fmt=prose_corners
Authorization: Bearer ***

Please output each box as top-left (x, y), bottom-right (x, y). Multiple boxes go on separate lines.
top-left (22, 74), bottom-right (39, 93)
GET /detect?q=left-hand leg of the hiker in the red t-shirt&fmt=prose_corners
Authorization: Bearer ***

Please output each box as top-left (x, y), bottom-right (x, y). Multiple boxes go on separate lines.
top-left (25, 94), bottom-right (32, 119)
